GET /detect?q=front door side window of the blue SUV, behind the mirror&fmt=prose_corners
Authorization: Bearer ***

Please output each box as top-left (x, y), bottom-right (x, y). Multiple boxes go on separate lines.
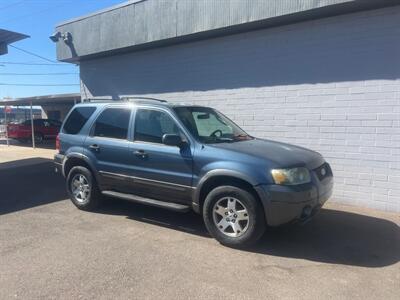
top-left (135, 109), bottom-right (180, 144)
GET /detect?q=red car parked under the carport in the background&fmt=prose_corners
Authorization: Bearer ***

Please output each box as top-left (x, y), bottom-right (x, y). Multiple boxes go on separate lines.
top-left (7, 119), bottom-right (61, 143)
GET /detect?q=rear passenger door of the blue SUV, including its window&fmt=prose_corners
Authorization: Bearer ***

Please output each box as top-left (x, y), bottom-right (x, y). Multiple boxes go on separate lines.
top-left (84, 106), bottom-right (132, 192)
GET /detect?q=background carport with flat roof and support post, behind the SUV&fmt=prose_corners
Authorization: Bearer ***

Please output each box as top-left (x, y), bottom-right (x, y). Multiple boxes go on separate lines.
top-left (0, 93), bottom-right (81, 148)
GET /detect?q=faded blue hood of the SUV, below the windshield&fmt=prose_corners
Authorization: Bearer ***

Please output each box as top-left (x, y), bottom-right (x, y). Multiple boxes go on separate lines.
top-left (208, 138), bottom-right (325, 170)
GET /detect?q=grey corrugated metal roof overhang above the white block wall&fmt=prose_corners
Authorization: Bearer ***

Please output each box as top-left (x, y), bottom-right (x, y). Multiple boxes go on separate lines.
top-left (56, 0), bottom-right (399, 63)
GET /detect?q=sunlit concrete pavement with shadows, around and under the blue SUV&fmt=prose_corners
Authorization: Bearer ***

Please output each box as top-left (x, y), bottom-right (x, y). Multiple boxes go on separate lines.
top-left (0, 146), bottom-right (400, 299)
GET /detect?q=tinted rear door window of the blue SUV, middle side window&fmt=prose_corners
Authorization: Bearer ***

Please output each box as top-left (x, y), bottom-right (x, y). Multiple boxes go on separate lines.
top-left (93, 108), bottom-right (131, 139)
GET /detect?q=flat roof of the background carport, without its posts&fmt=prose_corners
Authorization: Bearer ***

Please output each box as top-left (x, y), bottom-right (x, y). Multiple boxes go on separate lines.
top-left (0, 93), bottom-right (81, 106)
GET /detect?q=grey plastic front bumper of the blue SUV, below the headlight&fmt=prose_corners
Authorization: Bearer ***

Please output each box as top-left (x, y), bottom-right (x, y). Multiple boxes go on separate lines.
top-left (255, 177), bottom-right (333, 226)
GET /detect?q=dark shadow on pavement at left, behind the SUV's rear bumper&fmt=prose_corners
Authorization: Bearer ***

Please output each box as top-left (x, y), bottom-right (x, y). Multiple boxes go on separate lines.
top-left (0, 157), bottom-right (68, 215)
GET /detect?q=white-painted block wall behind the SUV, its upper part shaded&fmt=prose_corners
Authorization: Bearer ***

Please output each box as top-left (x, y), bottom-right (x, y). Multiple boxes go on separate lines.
top-left (80, 7), bottom-right (400, 212)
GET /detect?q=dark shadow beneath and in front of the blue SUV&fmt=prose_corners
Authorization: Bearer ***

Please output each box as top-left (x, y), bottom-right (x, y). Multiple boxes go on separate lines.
top-left (98, 199), bottom-right (400, 268)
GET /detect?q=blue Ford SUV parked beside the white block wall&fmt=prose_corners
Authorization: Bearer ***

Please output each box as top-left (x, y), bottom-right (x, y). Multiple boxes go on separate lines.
top-left (55, 99), bottom-right (333, 247)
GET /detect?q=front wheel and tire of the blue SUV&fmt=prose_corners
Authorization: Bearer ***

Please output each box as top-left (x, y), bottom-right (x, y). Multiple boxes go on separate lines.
top-left (203, 186), bottom-right (266, 248)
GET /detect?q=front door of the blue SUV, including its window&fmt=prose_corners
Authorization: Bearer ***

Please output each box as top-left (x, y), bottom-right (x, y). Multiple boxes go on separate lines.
top-left (130, 108), bottom-right (193, 203)
